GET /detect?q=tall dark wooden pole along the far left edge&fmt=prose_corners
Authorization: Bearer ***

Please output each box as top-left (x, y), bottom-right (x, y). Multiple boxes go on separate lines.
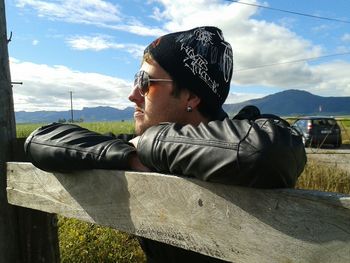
top-left (0, 0), bottom-right (21, 262)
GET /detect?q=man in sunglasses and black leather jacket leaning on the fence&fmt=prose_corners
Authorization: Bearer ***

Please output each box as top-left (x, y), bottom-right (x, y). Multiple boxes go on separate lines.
top-left (25, 27), bottom-right (306, 262)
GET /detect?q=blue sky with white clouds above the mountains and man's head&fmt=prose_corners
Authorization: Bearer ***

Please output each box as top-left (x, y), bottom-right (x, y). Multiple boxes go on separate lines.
top-left (5, 0), bottom-right (350, 111)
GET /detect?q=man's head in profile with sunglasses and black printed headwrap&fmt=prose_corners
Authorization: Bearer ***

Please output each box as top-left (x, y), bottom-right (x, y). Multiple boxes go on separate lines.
top-left (129, 27), bottom-right (233, 172)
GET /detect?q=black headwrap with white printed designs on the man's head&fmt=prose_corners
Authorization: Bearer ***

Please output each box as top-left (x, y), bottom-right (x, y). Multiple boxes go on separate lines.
top-left (144, 26), bottom-right (233, 117)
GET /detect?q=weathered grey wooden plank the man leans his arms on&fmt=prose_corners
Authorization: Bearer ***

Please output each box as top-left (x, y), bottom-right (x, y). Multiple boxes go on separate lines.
top-left (7, 163), bottom-right (350, 263)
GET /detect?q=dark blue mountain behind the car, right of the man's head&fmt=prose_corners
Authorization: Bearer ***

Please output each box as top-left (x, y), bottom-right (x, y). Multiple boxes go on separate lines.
top-left (224, 90), bottom-right (350, 116)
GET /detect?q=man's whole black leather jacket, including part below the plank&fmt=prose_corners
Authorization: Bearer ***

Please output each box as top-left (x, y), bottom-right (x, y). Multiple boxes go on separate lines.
top-left (25, 113), bottom-right (306, 262)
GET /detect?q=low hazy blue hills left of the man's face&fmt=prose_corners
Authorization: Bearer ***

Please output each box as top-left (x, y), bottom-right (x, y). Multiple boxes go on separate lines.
top-left (15, 107), bottom-right (134, 123)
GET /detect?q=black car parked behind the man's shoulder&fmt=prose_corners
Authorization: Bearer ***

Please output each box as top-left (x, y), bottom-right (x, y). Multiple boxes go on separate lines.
top-left (292, 116), bottom-right (342, 147)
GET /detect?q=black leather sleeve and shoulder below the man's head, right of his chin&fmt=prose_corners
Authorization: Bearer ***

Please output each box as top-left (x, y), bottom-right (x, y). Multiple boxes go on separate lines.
top-left (137, 118), bottom-right (306, 188)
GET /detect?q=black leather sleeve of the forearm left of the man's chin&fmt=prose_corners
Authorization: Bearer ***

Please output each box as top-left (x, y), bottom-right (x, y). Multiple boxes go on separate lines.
top-left (24, 123), bottom-right (136, 171)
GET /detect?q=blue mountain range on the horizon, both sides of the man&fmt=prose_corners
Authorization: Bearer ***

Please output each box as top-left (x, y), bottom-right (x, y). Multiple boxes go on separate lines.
top-left (15, 90), bottom-right (350, 123)
